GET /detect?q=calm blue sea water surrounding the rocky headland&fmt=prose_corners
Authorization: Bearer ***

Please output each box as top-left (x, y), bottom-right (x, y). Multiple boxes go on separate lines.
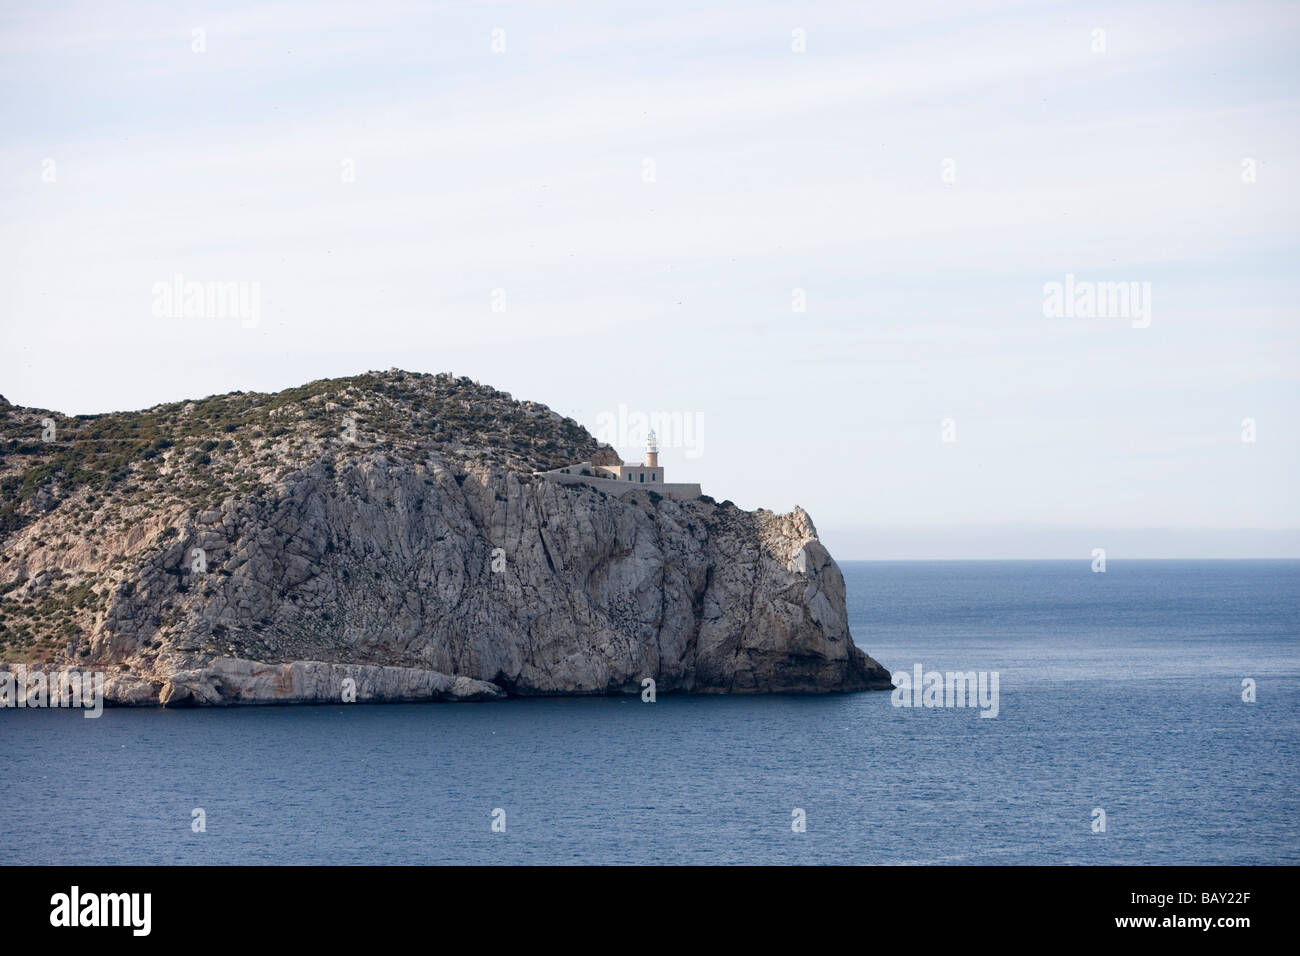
top-left (0, 561), bottom-right (1300, 864)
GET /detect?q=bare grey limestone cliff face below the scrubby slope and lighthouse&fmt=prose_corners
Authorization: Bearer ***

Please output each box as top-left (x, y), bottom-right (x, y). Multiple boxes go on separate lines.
top-left (0, 369), bottom-right (891, 706)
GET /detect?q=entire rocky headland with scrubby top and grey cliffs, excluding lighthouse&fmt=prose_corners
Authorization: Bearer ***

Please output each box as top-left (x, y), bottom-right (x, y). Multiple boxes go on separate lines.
top-left (0, 369), bottom-right (891, 705)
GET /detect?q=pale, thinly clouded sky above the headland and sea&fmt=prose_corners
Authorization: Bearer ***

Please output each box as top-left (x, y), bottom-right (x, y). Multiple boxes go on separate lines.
top-left (0, 0), bottom-right (1300, 561)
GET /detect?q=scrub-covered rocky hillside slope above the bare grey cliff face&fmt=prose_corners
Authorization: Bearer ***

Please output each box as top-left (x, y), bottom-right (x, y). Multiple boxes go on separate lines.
top-left (0, 369), bottom-right (601, 659)
